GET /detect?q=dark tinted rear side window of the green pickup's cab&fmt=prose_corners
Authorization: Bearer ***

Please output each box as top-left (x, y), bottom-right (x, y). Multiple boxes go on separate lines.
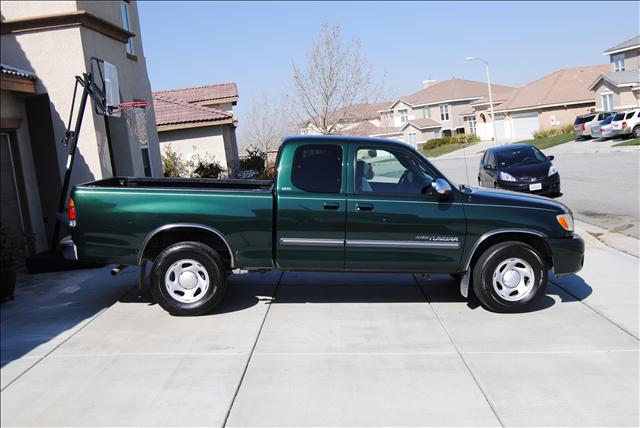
top-left (291, 144), bottom-right (342, 193)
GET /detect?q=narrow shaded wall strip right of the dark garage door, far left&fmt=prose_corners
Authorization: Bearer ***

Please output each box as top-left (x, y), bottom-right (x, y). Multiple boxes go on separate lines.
top-left (0, 91), bottom-right (47, 252)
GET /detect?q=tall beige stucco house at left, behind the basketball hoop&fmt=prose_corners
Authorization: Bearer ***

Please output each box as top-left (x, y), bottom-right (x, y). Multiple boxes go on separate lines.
top-left (0, 0), bottom-right (162, 254)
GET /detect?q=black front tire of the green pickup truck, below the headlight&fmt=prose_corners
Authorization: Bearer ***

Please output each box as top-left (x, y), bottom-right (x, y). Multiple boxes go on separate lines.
top-left (473, 241), bottom-right (547, 312)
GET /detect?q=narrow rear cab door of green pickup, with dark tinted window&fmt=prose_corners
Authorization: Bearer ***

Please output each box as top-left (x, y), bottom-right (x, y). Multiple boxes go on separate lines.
top-left (275, 141), bottom-right (346, 270)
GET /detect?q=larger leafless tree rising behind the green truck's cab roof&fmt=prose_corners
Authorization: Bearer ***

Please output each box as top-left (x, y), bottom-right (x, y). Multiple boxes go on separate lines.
top-left (288, 23), bottom-right (382, 134)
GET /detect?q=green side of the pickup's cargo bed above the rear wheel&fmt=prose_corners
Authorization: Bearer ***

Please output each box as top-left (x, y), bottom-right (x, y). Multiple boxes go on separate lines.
top-left (71, 177), bottom-right (273, 267)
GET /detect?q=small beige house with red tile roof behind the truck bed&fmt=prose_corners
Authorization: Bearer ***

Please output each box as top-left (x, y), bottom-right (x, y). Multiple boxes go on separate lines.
top-left (153, 83), bottom-right (238, 174)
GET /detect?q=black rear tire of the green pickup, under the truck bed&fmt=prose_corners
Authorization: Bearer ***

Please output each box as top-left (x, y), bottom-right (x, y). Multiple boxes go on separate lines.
top-left (151, 242), bottom-right (227, 316)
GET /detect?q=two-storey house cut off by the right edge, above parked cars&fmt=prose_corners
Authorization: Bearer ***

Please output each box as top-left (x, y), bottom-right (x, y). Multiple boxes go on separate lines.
top-left (589, 36), bottom-right (640, 111)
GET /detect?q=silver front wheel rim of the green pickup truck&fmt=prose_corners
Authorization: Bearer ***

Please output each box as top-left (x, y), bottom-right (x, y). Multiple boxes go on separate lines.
top-left (493, 258), bottom-right (536, 302)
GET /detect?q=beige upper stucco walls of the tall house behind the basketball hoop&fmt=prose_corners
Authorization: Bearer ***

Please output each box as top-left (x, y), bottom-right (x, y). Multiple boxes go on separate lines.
top-left (1, 1), bottom-right (161, 184)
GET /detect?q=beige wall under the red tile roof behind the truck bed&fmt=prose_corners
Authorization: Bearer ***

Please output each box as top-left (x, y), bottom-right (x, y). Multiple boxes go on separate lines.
top-left (159, 125), bottom-right (228, 168)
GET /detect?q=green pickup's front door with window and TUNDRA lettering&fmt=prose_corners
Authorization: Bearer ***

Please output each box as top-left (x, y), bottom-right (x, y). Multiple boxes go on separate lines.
top-left (345, 145), bottom-right (466, 273)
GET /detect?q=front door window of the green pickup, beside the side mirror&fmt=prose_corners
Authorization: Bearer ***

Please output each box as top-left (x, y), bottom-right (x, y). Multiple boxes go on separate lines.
top-left (354, 148), bottom-right (434, 195)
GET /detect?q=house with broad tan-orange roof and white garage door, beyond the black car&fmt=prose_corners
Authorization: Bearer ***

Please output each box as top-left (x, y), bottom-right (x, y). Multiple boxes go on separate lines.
top-left (490, 64), bottom-right (609, 141)
